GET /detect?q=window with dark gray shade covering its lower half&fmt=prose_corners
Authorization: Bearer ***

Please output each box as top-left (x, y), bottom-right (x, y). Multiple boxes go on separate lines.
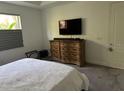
top-left (0, 14), bottom-right (23, 51)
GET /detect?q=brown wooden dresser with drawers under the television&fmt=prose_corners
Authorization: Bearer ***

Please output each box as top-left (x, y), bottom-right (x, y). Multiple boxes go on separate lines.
top-left (50, 38), bottom-right (85, 66)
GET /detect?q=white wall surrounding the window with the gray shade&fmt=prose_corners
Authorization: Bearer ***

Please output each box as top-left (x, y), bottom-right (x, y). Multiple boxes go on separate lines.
top-left (0, 2), bottom-right (43, 65)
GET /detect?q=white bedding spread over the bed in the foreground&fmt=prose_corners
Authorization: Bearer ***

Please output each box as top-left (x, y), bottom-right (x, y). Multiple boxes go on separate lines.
top-left (0, 58), bottom-right (89, 91)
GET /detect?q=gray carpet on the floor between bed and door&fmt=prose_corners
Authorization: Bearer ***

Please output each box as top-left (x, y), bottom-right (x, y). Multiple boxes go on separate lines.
top-left (71, 65), bottom-right (124, 91)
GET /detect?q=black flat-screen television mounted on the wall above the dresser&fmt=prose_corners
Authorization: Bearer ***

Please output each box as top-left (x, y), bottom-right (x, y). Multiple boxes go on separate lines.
top-left (59, 18), bottom-right (82, 35)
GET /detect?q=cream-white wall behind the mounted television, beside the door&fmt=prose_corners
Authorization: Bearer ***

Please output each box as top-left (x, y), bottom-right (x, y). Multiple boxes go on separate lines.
top-left (41, 1), bottom-right (119, 67)
